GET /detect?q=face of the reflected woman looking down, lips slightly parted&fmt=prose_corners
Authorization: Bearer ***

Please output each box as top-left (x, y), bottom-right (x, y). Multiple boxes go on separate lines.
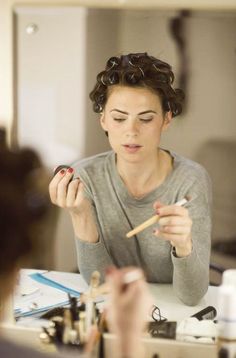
top-left (100, 85), bottom-right (172, 162)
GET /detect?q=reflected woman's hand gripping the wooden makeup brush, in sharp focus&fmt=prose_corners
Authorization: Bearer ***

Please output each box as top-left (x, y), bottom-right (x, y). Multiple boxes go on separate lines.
top-left (154, 201), bottom-right (192, 257)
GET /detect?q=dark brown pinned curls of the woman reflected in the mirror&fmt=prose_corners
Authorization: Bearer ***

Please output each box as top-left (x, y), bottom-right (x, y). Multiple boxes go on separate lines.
top-left (89, 52), bottom-right (184, 117)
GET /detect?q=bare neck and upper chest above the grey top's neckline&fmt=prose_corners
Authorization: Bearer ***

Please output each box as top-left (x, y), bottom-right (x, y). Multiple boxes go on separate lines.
top-left (117, 149), bottom-right (172, 198)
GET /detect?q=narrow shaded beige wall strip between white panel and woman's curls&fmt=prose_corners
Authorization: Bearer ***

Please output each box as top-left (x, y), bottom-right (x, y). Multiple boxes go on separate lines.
top-left (85, 9), bottom-right (120, 156)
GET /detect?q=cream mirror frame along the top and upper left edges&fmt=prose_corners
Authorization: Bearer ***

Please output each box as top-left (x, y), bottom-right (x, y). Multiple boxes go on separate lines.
top-left (0, 0), bottom-right (236, 143)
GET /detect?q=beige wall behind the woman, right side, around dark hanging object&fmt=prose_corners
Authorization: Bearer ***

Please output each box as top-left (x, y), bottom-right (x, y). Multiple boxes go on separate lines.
top-left (120, 11), bottom-right (236, 158)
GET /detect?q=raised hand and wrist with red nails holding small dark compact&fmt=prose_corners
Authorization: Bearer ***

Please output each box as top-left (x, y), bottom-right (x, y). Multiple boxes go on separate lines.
top-left (49, 168), bottom-right (98, 243)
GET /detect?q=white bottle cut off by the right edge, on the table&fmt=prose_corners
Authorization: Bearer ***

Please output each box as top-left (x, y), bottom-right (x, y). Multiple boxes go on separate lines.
top-left (217, 269), bottom-right (236, 358)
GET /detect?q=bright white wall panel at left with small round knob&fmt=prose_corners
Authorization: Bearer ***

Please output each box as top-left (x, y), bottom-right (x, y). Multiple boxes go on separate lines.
top-left (16, 7), bottom-right (87, 168)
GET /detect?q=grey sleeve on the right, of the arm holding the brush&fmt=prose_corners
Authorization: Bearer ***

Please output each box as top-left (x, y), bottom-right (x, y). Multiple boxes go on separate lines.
top-left (172, 170), bottom-right (212, 306)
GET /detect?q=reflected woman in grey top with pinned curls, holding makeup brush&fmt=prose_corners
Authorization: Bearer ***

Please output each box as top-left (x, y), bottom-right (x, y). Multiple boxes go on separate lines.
top-left (49, 53), bottom-right (211, 305)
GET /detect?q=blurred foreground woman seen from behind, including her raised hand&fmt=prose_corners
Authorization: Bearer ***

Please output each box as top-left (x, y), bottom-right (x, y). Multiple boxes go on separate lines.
top-left (0, 130), bottom-right (151, 358)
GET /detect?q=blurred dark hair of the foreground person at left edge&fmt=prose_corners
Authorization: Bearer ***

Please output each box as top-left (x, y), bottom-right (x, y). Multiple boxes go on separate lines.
top-left (0, 130), bottom-right (49, 275)
